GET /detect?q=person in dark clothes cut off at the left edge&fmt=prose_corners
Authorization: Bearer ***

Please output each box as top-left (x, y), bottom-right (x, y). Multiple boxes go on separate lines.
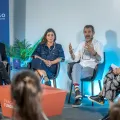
top-left (0, 43), bottom-right (11, 85)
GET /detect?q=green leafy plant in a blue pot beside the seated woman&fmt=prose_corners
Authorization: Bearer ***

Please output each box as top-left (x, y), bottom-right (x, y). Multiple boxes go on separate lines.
top-left (6, 39), bottom-right (32, 69)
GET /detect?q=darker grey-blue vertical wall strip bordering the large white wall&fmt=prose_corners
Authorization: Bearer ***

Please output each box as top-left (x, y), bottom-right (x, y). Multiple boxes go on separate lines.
top-left (14, 0), bottom-right (26, 40)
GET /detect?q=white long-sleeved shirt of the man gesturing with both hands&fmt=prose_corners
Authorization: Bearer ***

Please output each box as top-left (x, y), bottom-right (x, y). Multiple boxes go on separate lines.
top-left (74, 39), bottom-right (104, 68)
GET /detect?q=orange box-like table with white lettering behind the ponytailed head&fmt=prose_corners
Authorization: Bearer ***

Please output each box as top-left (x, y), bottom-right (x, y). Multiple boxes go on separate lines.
top-left (0, 85), bottom-right (66, 118)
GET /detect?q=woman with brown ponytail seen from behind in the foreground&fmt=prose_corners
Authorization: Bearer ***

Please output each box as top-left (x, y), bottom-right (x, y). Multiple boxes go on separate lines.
top-left (11, 70), bottom-right (48, 120)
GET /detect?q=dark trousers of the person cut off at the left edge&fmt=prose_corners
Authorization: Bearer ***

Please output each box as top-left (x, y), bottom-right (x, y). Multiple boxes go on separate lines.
top-left (0, 62), bottom-right (11, 85)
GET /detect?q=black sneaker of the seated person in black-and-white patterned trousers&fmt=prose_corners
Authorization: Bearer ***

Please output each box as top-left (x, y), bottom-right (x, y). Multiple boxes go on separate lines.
top-left (88, 95), bottom-right (105, 105)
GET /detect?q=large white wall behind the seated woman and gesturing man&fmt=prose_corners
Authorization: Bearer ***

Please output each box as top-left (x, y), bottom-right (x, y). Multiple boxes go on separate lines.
top-left (19, 0), bottom-right (120, 92)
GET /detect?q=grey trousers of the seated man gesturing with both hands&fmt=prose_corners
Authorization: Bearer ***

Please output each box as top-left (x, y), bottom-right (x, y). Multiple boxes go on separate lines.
top-left (71, 63), bottom-right (94, 84)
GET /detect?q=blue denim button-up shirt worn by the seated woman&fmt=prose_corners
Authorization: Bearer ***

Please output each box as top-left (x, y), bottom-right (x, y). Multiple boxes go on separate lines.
top-left (33, 43), bottom-right (65, 73)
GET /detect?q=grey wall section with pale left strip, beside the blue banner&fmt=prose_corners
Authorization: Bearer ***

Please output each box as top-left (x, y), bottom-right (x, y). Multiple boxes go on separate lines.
top-left (9, 0), bottom-right (26, 44)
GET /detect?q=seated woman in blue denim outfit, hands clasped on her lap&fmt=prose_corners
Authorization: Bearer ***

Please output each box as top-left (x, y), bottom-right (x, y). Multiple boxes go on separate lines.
top-left (32, 28), bottom-right (65, 85)
